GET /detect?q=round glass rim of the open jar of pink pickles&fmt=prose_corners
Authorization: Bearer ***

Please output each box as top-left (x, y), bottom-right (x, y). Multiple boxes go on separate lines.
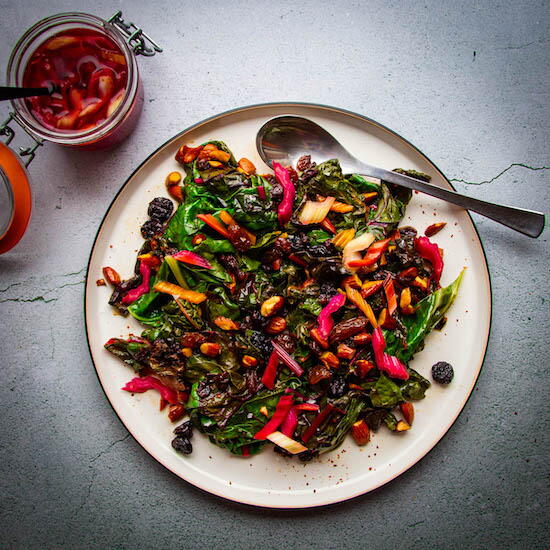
top-left (6, 12), bottom-right (139, 145)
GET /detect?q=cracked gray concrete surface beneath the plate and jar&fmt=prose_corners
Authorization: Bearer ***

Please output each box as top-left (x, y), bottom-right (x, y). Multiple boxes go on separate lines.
top-left (0, 0), bottom-right (550, 550)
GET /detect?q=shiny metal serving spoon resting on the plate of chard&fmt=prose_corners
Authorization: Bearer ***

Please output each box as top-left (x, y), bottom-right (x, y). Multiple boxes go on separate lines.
top-left (256, 116), bottom-right (544, 238)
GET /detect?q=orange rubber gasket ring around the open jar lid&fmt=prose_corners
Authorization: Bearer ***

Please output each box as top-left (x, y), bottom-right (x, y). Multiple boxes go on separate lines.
top-left (0, 143), bottom-right (32, 254)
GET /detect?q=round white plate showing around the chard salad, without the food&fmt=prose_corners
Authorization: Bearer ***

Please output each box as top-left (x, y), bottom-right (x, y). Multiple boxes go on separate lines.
top-left (85, 103), bottom-right (491, 508)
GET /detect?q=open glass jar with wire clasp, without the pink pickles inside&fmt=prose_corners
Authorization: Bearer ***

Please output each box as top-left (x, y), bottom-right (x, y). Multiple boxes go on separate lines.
top-left (7, 12), bottom-right (162, 149)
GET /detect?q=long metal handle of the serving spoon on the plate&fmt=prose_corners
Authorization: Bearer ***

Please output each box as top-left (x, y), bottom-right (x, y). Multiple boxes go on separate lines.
top-left (353, 163), bottom-right (544, 238)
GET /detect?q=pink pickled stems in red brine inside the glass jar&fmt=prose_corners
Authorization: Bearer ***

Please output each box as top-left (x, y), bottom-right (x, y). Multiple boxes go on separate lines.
top-left (23, 29), bottom-right (128, 132)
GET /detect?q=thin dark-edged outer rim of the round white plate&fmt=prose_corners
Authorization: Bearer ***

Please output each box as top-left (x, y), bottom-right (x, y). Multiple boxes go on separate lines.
top-left (83, 101), bottom-right (493, 510)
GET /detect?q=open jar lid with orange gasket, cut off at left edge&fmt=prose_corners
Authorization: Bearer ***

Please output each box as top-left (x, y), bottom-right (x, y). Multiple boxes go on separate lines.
top-left (0, 142), bottom-right (32, 254)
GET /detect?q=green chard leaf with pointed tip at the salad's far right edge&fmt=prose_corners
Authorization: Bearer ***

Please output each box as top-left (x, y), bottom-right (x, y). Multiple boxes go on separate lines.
top-left (384, 270), bottom-right (464, 363)
